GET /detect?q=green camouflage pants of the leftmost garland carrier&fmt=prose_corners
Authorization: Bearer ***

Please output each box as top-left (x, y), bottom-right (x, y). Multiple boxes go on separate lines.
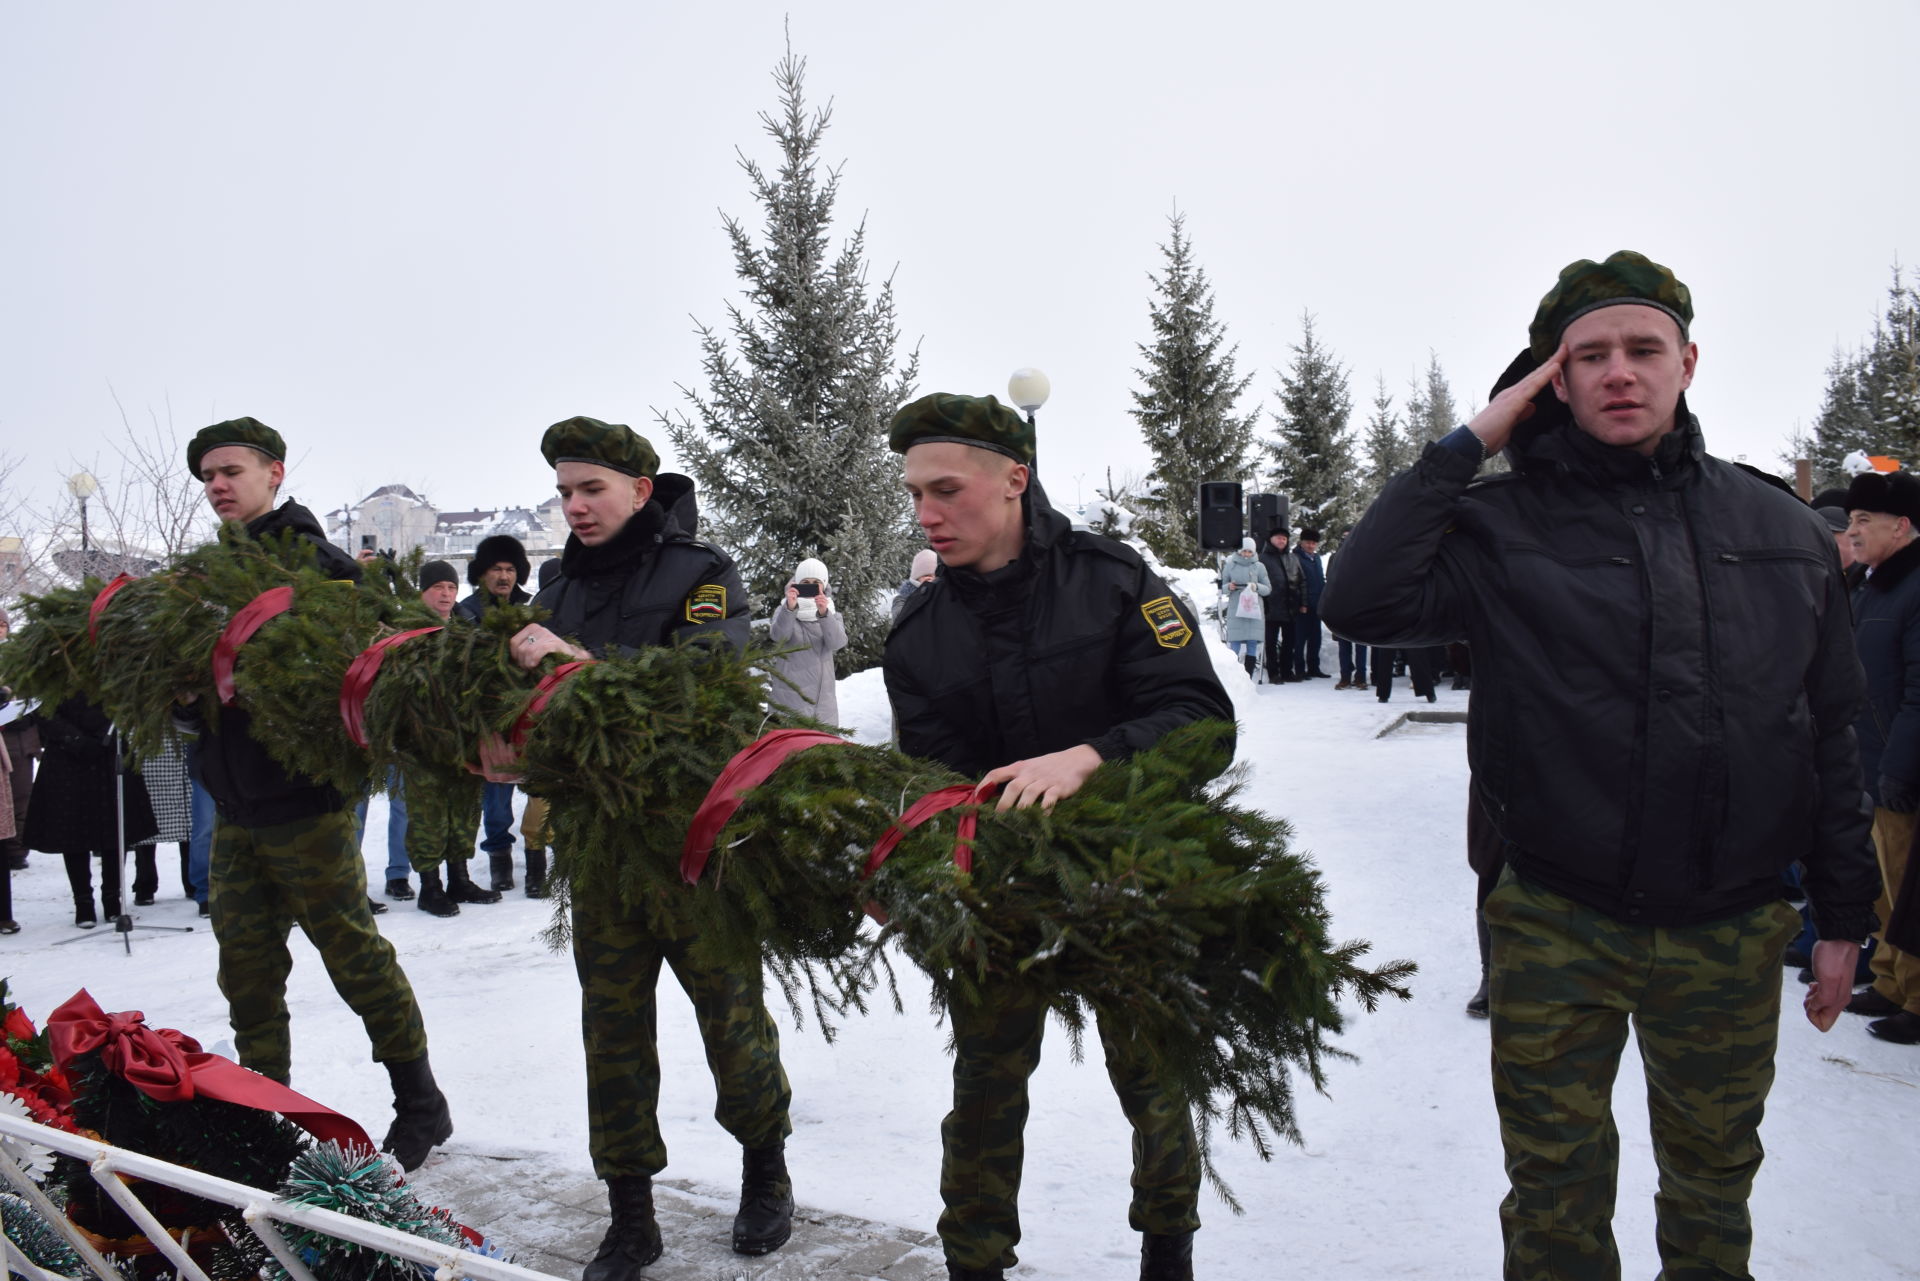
top-left (207, 810), bottom-right (426, 1081)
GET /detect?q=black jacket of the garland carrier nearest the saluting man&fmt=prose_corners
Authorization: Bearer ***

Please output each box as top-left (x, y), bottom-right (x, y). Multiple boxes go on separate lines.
top-left (885, 482), bottom-right (1233, 778)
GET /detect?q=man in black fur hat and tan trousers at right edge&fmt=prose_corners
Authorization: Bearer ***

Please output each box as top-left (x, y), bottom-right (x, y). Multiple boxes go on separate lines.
top-left (1847, 471), bottom-right (1920, 1045)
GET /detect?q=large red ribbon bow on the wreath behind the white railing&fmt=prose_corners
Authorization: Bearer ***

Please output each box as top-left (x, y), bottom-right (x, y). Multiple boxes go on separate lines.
top-left (46, 987), bottom-right (372, 1152)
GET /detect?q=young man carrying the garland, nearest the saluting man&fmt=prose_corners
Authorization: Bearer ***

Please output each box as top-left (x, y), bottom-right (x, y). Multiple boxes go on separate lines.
top-left (885, 394), bottom-right (1233, 1281)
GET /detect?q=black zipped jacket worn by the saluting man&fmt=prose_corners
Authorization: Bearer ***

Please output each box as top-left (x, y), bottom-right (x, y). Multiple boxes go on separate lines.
top-left (1321, 416), bottom-right (1880, 939)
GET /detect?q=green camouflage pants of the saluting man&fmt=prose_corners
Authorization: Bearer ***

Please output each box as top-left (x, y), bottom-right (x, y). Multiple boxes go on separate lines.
top-left (1484, 868), bottom-right (1799, 1281)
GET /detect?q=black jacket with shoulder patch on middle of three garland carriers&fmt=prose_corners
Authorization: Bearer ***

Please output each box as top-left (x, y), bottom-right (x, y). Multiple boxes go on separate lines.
top-left (534, 472), bottom-right (749, 657)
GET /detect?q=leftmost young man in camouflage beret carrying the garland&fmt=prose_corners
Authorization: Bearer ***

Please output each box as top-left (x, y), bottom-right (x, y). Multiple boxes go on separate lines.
top-left (180, 419), bottom-right (453, 1170)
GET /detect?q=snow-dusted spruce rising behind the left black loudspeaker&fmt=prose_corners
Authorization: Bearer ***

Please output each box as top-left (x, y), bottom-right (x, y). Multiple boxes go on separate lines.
top-left (1129, 213), bottom-right (1260, 567)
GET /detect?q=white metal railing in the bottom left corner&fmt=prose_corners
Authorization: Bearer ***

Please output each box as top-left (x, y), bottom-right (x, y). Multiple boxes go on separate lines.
top-left (0, 1114), bottom-right (555, 1281)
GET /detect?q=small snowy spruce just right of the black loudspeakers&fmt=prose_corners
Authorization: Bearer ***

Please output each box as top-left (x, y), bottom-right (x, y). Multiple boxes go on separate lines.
top-left (1261, 311), bottom-right (1359, 542)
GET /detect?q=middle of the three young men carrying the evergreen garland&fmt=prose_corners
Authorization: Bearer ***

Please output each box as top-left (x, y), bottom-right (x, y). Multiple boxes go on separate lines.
top-left (511, 417), bottom-right (793, 1281)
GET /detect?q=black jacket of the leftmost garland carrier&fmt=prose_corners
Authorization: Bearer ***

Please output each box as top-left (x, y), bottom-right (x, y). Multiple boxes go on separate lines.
top-left (200, 501), bottom-right (361, 828)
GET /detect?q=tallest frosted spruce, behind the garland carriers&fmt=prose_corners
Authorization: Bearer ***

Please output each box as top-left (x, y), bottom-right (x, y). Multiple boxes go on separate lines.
top-left (659, 52), bottom-right (920, 674)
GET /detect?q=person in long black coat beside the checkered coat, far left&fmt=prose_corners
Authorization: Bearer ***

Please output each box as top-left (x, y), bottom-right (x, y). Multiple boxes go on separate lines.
top-left (25, 697), bottom-right (156, 930)
